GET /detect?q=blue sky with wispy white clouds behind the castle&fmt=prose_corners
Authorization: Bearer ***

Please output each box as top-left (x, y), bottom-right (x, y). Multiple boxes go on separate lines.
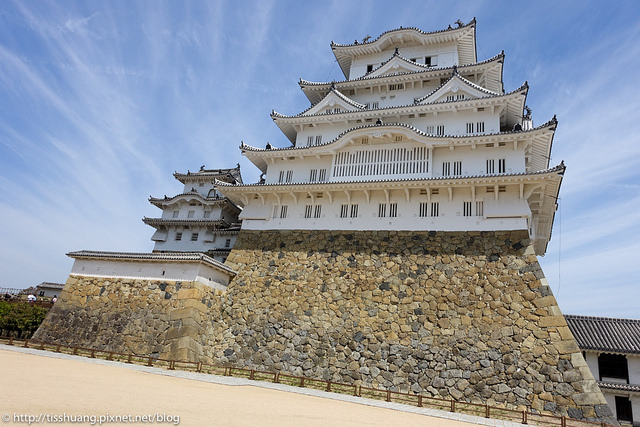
top-left (0, 0), bottom-right (640, 318)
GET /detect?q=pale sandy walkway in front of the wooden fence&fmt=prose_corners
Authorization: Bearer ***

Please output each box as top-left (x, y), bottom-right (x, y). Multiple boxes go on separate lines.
top-left (0, 345), bottom-right (520, 427)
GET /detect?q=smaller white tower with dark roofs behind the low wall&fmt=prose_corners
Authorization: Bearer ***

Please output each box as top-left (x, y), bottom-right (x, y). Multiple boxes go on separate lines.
top-left (143, 165), bottom-right (242, 262)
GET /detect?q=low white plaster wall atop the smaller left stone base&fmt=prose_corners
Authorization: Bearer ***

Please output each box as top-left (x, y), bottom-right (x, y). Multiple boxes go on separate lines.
top-left (71, 259), bottom-right (231, 289)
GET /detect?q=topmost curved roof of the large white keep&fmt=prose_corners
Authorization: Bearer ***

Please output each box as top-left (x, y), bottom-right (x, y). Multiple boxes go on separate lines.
top-left (331, 18), bottom-right (477, 79)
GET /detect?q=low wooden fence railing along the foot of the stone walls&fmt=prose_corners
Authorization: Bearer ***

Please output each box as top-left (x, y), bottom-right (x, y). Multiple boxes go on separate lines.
top-left (0, 337), bottom-right (614, 427)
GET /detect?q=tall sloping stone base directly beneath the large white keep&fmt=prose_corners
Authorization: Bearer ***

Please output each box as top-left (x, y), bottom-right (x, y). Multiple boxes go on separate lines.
top-left (211, 230), bottom-right (615, 423)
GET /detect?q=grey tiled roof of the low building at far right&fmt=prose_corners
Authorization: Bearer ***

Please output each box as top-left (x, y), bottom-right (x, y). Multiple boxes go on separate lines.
top-left (565, 315), bottom-right (640, 354)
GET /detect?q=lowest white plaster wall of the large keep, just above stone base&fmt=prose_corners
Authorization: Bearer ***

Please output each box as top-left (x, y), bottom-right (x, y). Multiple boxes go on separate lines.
top-left (240, 188), bottom-right (530, 231)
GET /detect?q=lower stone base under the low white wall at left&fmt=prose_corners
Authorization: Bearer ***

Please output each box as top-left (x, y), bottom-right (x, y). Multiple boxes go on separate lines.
top-left (32, 275), bottom-right (223, 361)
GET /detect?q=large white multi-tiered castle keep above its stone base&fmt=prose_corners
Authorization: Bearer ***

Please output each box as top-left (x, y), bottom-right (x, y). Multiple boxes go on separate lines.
top-left (217, 19), bottom-right (565, 255)
